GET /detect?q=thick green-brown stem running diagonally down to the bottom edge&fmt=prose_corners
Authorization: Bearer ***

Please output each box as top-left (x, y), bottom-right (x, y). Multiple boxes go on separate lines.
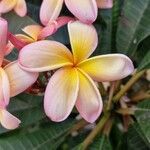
top-left (82, 112), bottom-right (110, 150)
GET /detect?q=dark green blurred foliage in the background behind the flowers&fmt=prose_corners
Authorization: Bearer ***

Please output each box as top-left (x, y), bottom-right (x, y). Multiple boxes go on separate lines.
top-left (0, 0), bottom-right (150, 150)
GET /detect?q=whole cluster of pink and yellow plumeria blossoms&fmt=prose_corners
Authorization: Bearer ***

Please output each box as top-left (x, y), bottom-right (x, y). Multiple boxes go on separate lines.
top-left (0, 0), bottom-right (134, 129)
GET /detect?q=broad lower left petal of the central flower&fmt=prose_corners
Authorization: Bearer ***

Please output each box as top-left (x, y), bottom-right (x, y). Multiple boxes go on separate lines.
top-left (44, 68), bottom-right (79, 122)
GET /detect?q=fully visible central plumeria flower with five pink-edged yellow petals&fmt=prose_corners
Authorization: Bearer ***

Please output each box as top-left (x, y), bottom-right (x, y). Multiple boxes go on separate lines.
top-left (19, 21), bottom-right (134, 123)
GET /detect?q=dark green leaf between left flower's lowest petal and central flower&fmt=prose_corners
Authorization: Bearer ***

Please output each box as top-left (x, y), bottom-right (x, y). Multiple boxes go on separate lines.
top-left (0, 94), bottom-right (46, 134)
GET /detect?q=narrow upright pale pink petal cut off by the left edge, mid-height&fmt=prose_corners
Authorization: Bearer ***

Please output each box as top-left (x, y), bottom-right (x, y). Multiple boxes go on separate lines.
top-left (0, 68), bottom-right (10, 108)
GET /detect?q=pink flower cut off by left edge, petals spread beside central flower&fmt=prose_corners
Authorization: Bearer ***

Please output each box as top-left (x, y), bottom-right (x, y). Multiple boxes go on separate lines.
top-left (0, 18), bottom-right (38, 129)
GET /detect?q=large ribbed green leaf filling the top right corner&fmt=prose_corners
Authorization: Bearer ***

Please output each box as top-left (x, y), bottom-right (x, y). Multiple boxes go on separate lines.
top-left (116, 0), bottom-right (150, 55)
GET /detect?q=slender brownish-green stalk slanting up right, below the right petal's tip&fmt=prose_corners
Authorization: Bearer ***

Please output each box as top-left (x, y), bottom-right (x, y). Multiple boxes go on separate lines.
top-left (113, 70), bottom-right (145, 103)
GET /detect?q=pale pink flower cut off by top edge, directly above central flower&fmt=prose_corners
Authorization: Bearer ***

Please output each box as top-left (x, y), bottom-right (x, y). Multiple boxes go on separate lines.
top-left (40, 0), bottom-right (113, 26)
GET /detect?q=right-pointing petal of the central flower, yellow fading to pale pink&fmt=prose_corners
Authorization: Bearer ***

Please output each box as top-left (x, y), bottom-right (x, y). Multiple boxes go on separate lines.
top-left (78, 54), bottom-right (134, 81)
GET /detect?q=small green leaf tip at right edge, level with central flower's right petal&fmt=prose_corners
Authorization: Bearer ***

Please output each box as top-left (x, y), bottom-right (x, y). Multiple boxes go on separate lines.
top-left (138, 50), bottom-right (150, 71)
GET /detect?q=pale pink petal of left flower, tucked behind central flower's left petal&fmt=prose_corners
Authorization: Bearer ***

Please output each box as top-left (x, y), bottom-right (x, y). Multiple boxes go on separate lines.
top-left (4, 61), bottom-right (38, 97)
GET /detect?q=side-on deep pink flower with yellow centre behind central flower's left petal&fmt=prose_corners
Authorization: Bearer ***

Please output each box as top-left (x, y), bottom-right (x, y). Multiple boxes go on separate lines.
top-left (5, 16), bottom-right (75, 55)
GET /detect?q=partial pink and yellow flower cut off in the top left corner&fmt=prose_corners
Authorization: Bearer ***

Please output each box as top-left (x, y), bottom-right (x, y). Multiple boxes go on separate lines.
top-left (0, 0), bottom-right (27, 17)
